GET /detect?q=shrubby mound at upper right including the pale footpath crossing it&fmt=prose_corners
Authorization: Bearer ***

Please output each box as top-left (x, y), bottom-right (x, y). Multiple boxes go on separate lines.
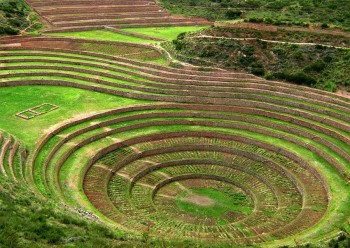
top-left (166, 27), bottom-right (350, 92)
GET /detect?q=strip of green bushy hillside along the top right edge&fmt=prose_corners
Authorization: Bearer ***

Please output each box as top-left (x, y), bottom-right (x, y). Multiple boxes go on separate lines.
top-left (161, 0), bottom-right (350, 29)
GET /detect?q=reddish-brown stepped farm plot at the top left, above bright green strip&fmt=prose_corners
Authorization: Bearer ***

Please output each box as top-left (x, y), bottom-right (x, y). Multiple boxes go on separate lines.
top-left (26, 0), bottom-right (209, 32)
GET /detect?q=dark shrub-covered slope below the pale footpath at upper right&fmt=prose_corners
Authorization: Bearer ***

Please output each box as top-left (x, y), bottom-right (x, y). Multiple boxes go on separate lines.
top-left (172, 29), bottom-right (350, 92)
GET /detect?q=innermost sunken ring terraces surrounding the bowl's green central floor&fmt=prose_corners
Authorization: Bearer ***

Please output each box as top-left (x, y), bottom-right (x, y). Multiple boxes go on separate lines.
top-left (90, 132), bottom-right (327, 243)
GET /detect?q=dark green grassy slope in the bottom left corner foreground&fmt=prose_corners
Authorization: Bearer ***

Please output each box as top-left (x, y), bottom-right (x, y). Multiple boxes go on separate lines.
top-left (0, 177), bottom-right (138, 248)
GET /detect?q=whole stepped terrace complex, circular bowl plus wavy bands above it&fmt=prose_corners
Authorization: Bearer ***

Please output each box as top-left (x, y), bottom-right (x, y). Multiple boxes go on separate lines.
top-left (0, 38), bottom-right (350, 244)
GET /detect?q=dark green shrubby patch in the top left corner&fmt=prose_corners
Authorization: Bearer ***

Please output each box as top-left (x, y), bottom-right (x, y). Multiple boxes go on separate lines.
top-left (0, 0), bottom-right (42, 36)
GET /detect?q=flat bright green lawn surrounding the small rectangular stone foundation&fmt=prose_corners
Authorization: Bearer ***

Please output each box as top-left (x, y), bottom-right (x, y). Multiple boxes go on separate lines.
top-left (0, 86), bottom-right (145, 147)
